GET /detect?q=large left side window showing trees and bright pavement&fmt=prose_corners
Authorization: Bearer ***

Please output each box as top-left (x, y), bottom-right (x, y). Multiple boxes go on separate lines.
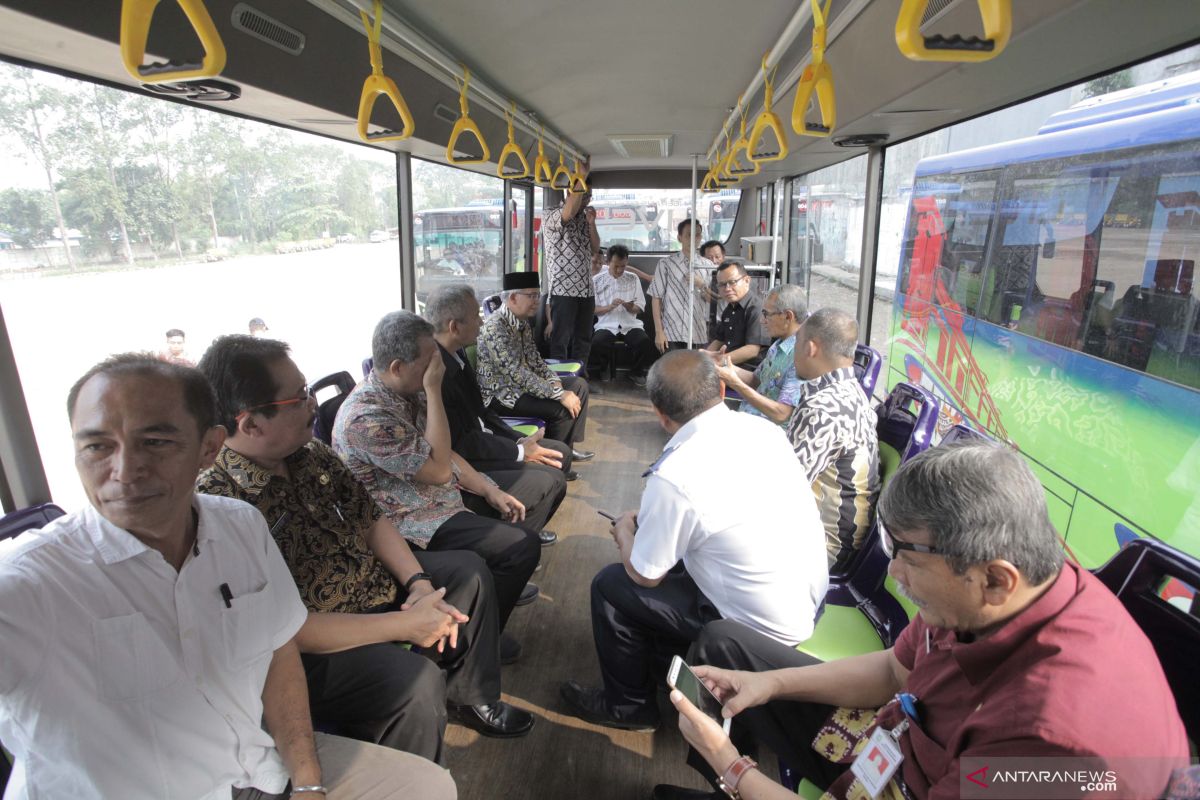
top-left (0, 65), bottom-right (401, 509)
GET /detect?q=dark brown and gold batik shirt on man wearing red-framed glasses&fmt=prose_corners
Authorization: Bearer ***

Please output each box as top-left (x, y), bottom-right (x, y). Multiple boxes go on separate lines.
top-left (196, 440), bottom-right (396, 614)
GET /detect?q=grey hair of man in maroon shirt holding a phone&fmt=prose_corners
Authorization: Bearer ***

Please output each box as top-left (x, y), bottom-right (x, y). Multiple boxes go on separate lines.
top-left (876, 441), bottom-right (1063, 585)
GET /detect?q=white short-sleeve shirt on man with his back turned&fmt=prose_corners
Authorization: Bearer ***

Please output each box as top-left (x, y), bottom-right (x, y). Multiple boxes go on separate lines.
top-left (630, 405), bottom-right (829, 645)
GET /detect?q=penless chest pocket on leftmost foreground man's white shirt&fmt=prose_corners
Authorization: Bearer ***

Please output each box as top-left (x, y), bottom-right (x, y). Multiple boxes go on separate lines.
top-left (91, 613), bottom-right (180, 700)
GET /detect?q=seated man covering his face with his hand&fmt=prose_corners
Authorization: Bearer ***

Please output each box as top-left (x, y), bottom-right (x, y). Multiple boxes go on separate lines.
top-left (334, 311), bottom-right (541, 631)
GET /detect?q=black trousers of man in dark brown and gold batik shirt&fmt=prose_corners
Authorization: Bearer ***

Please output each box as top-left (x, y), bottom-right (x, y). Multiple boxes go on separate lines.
top-left (300, 551), bottom-right (500, 763)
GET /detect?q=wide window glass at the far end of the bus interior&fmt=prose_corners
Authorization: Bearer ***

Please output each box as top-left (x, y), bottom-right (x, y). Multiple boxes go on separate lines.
top-left (592, 188), bottom-right (720, 252)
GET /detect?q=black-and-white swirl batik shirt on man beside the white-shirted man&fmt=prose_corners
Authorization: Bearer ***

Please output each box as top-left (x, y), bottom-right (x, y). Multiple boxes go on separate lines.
top-left (787, 367), bottom-right (880, 569)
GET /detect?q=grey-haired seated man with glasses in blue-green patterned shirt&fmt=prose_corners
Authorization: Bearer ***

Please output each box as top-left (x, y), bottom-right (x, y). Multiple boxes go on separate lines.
top-left (713, 283), bottom-right (809, 425)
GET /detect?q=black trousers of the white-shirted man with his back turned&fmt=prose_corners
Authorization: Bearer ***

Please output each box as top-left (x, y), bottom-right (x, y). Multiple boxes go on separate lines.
top-left (592, 564), bottom-right (720, 721)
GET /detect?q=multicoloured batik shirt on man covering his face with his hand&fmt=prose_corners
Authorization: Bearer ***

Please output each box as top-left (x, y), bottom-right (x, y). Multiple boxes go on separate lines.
top-left (334, 369), bottom-right (466, 547)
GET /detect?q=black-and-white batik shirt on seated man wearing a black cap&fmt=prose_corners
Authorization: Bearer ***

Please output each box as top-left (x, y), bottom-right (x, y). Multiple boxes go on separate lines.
top-left (478, 304), bottom-right (564, 408)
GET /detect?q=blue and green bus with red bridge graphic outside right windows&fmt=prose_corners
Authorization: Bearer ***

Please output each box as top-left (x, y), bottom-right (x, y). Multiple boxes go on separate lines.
top-left (889, 73), bottom-right (1200, 568)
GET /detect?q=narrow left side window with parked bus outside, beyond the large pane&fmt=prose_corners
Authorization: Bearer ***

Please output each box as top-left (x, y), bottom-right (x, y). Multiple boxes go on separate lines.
top-left (413, 158), bottom-right (511, 305)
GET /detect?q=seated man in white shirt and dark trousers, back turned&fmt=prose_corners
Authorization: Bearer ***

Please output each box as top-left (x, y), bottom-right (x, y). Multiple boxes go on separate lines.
top-left (562, 350), bottom-right (828, 729)
